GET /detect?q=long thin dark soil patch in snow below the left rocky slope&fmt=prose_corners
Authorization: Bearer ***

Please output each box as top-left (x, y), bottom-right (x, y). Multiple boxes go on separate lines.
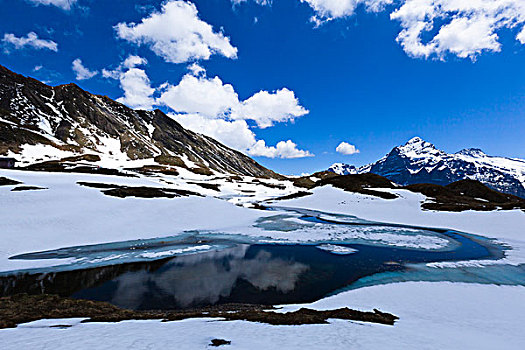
top-left (77, 181), bottom-right (202, 198)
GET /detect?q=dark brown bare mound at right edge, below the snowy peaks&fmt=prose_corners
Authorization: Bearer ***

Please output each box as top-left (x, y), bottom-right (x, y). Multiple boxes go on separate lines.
top-left (405, 180), bottom-right (525, 211)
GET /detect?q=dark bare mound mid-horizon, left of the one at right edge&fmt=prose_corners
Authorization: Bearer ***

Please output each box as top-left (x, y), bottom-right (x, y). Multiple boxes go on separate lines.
top-left (315, 173), bottom-right (397, 199)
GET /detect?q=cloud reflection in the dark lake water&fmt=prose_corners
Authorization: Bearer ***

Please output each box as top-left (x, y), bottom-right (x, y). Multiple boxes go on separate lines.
top-left (111, 245), bottom-right (308, 308)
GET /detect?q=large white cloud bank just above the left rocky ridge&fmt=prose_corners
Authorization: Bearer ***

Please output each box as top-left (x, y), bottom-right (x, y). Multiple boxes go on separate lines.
top-left (102, 56), bottom-right (313, 158)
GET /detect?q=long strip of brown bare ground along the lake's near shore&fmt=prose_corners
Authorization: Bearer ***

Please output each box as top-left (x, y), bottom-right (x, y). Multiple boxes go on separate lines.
top-left (0, 294), bottom-right (398, 328)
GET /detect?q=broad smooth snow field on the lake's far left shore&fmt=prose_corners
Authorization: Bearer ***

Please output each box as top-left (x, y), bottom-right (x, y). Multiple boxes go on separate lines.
top-left (0, 170), bottom-right (271, 271)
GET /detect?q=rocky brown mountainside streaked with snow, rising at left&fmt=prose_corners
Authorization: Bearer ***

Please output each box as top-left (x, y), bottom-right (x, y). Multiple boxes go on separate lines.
top-left (0, 66), bottom-right (277, 177)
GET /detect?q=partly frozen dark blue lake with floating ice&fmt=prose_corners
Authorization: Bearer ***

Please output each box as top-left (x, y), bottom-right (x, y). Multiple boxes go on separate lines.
top-left (0, 206), bottom-right (525, 309)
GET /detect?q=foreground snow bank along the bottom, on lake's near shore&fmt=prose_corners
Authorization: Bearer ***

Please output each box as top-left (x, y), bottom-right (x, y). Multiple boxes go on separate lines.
top-left (0, 282), bottom-right (525, 350)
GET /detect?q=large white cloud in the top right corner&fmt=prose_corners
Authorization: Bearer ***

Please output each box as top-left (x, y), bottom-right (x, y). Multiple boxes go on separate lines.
top-left (391, 0), bottom-right (525, 59)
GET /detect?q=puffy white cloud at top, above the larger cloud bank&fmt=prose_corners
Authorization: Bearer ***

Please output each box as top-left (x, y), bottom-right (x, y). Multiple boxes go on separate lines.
top-left (115, 0), bottom-right (237, 63)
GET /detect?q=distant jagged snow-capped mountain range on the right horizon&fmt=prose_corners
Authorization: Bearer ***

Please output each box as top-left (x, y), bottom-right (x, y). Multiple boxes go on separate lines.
top-left (328, 137), bottom-right (525, 198)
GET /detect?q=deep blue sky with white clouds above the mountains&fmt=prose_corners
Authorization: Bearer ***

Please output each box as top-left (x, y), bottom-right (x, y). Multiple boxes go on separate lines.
top-left (0, 0), bottom-right (525, 174)
